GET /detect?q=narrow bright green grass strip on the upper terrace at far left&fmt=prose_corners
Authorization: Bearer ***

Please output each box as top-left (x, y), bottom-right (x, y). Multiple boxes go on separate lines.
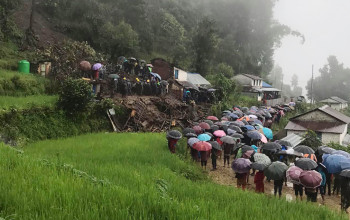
top-left (0, 95), bottom-right (58, 110)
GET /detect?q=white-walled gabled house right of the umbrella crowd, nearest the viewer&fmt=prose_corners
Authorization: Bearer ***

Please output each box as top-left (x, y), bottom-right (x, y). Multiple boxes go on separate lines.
top-left (285, 105), bottom-right (350, 144)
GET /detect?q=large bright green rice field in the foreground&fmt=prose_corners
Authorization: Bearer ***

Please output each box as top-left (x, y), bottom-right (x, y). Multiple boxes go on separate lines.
top-left (0, 134), bottom-right (340, 220)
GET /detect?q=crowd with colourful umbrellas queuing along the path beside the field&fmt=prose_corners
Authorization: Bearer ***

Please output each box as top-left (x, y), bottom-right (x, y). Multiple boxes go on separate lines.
top-left (167, 103), bottom-right (350, 214)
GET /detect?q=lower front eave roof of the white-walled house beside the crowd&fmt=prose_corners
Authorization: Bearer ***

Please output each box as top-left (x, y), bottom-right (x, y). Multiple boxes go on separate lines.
top-left (285, 121), bottom-right (346, 134)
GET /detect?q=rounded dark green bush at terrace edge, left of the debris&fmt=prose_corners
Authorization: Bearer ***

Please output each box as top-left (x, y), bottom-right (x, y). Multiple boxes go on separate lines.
top-left (57, 78), bottom-right (92, 115)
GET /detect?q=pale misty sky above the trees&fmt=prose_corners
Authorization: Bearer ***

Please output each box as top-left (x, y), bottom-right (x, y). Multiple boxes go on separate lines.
top-left (274, 0), bottom-right (350, 95)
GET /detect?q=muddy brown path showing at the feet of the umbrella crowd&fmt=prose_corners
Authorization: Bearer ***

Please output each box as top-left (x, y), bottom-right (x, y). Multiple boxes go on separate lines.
top-left (202, 158), bottom-right (350, 219)
